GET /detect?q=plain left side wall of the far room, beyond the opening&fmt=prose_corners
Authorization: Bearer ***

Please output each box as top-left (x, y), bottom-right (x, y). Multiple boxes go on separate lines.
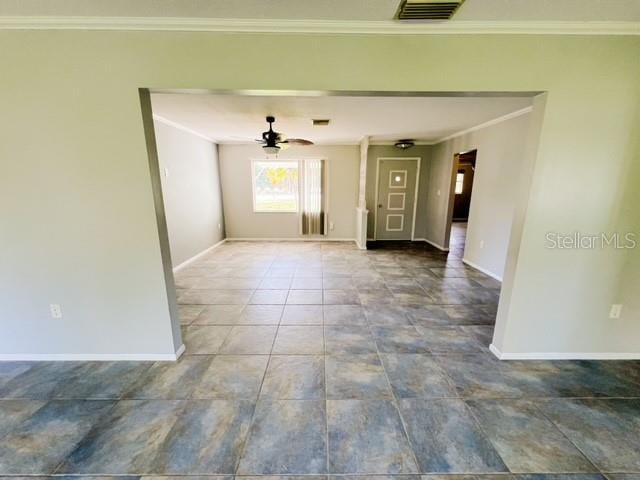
top-left (154, 121), bottom-right (224, 267)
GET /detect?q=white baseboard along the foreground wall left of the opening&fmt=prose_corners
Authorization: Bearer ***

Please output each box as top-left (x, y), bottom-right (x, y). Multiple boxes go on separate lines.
top-left (0, 344), bottom-right (185, 362)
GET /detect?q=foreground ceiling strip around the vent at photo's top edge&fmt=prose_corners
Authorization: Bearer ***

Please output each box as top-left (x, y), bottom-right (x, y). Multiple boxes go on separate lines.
top-left (0, 0), bottom-right (640, 22)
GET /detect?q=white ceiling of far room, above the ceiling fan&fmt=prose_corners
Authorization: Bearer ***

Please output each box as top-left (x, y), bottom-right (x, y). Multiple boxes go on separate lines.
top-left (151, 93), bottom-right (531, 144)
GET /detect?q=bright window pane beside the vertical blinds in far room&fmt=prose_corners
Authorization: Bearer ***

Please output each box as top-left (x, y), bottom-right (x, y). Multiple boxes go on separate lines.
top-left (252, 161), bottom-right (299, 212)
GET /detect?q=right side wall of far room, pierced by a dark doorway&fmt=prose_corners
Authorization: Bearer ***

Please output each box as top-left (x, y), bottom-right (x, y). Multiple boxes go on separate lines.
top-left (426, 110), bottom-right (529, 279)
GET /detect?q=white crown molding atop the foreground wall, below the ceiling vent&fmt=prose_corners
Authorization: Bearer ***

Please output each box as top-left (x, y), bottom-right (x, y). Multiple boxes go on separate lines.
top-left (0, 16), bottom-right (640, 35)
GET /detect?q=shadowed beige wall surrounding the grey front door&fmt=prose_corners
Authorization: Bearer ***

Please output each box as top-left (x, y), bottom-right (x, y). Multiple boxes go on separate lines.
top-left (366, 145), bottom-right (431, 239)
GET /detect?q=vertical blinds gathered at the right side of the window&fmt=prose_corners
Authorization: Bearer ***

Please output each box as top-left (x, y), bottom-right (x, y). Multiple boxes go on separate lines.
top-left (302, 160), bottom-right (325, 235)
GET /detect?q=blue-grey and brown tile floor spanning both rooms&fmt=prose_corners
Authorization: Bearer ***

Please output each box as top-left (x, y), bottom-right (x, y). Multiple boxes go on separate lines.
top-left (0, 226), bottom-right (640, 480)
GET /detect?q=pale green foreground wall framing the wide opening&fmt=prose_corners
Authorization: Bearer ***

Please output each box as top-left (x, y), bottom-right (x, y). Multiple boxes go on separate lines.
top-left (0, 30), bottom-right (640, 356)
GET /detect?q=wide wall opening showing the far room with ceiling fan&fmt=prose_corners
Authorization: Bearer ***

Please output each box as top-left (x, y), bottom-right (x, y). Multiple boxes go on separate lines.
top-left (140, 91), bottom-right (532, 355)
